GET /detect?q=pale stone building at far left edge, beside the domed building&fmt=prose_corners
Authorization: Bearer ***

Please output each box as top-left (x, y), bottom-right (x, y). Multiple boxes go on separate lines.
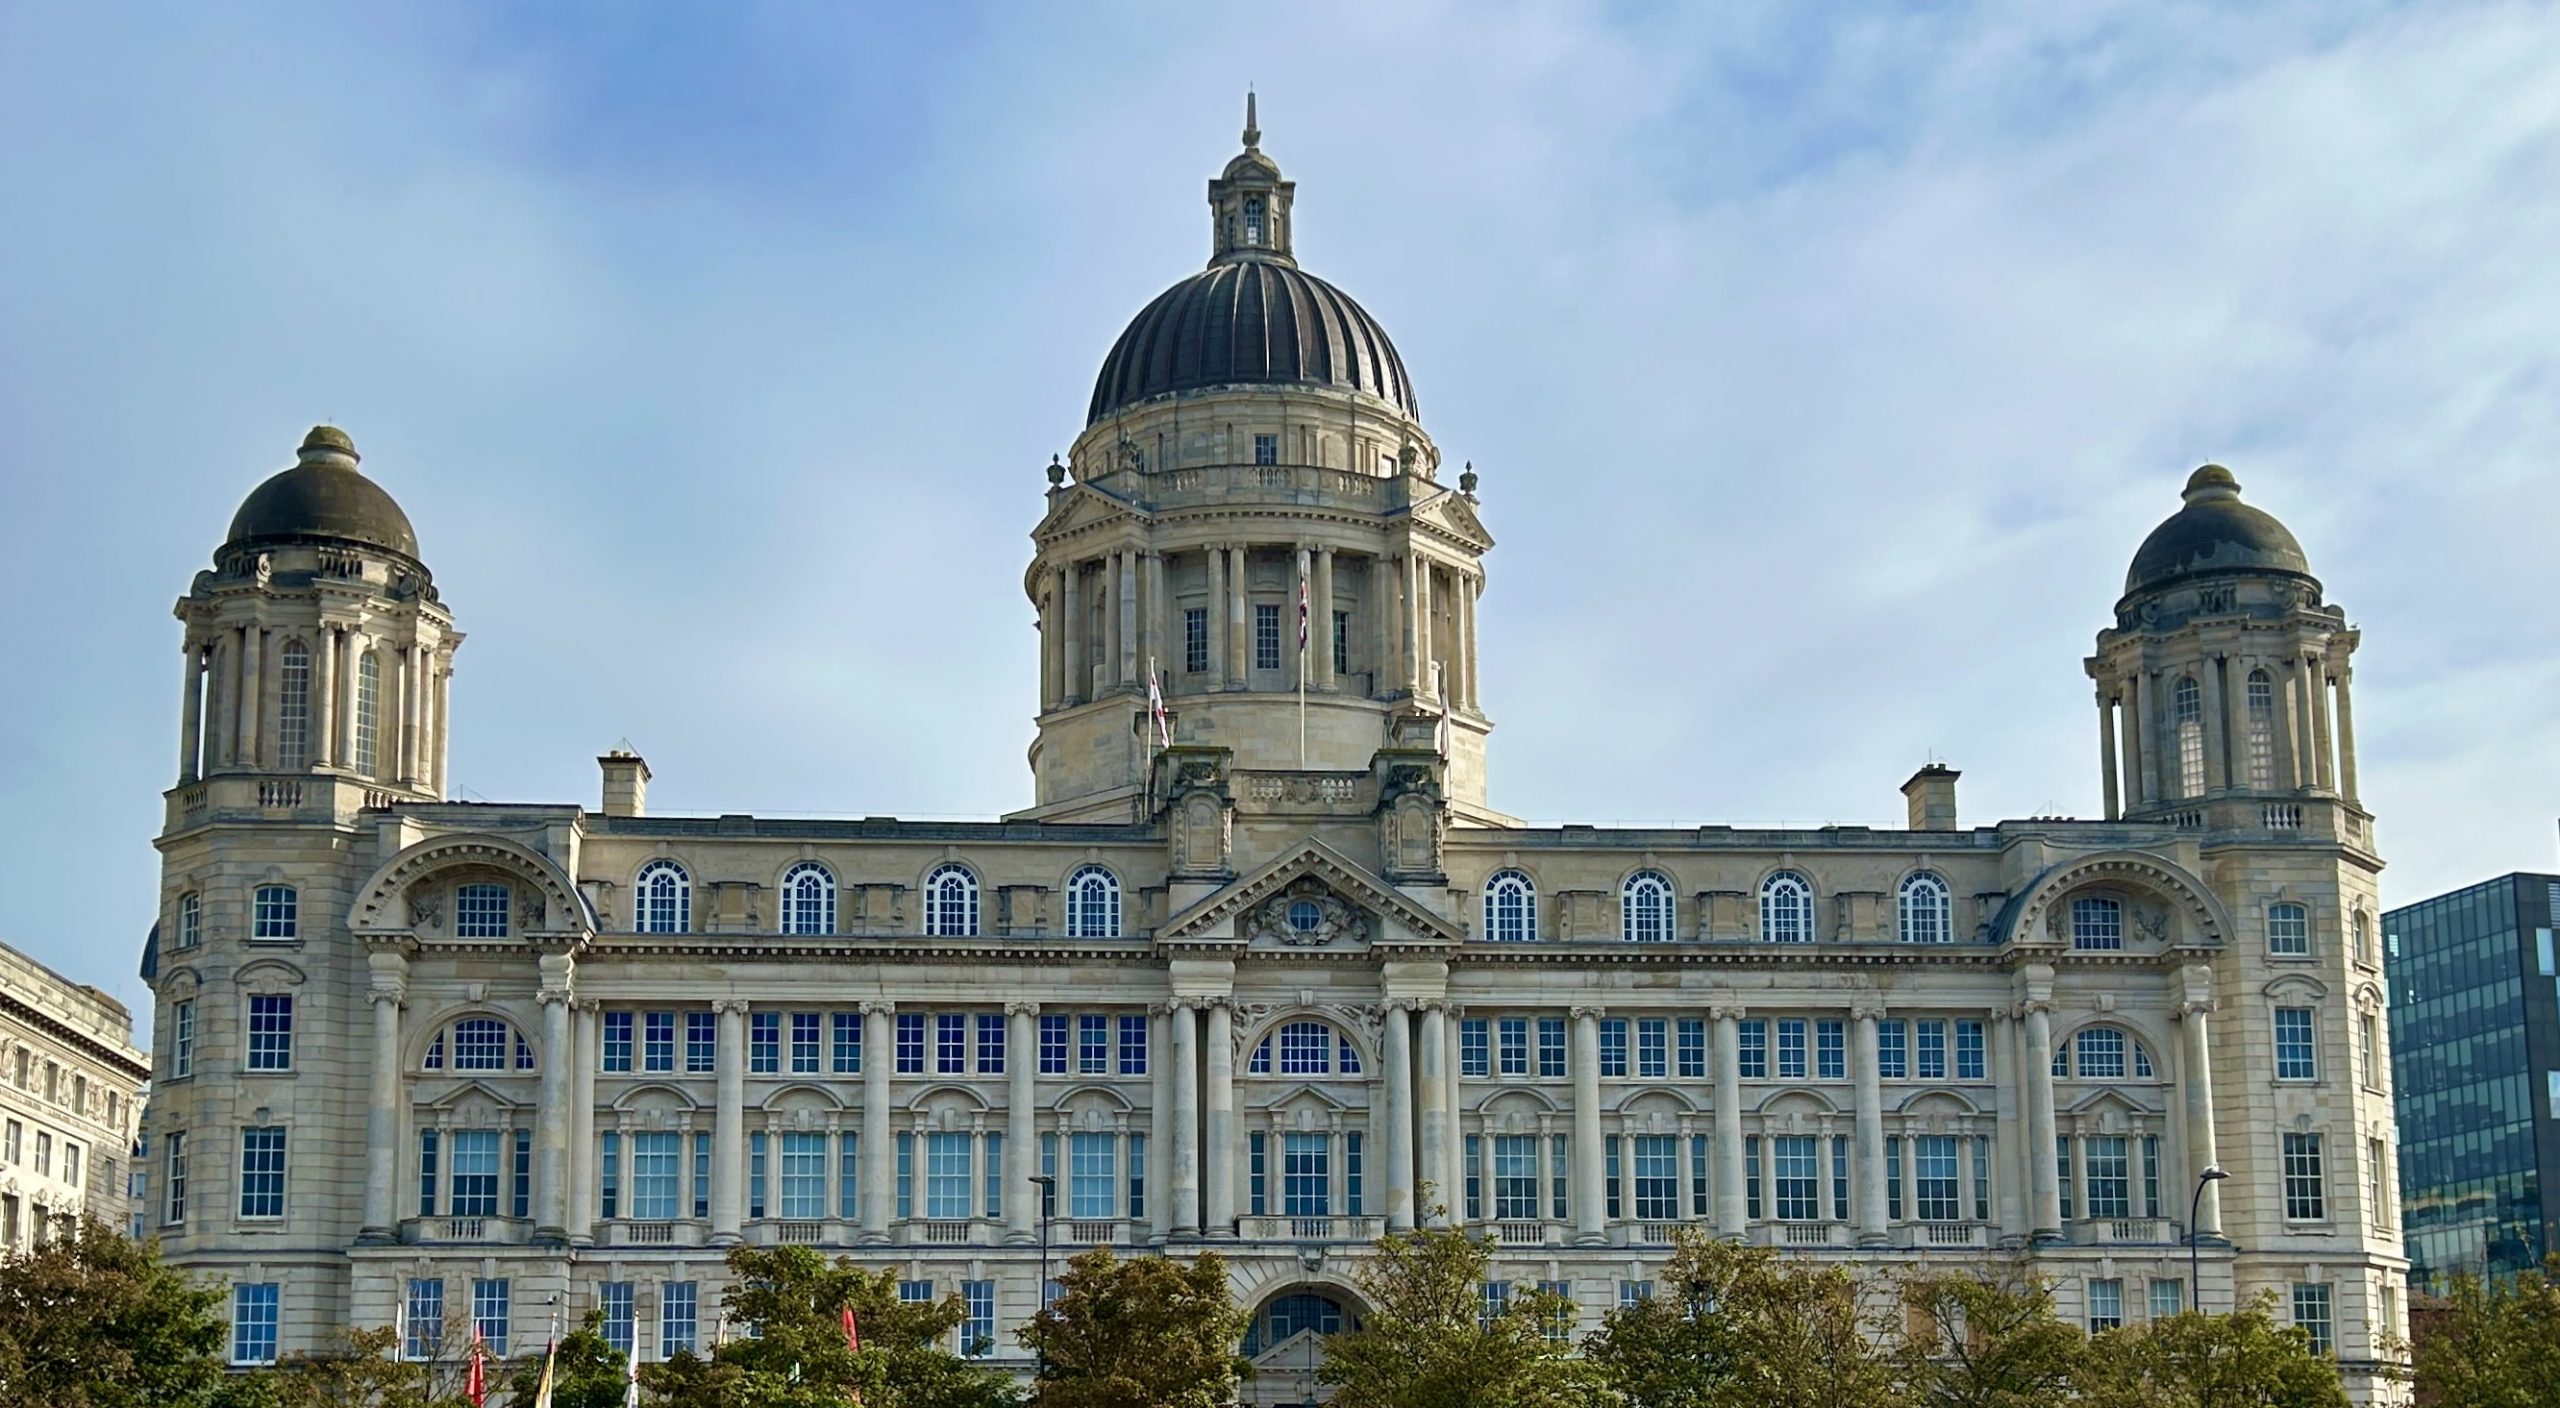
top-left (0, 945), bottom-right (151, 1254)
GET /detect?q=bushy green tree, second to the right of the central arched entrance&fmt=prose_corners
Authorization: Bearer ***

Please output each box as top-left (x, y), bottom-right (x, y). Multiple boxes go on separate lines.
top-left (1585, 1231), bottom-right (1902, 1408)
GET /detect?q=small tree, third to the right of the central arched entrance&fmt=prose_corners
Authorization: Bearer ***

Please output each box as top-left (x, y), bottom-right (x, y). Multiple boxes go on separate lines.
top-left (1894, 1270), bottom-right (2089, 1408)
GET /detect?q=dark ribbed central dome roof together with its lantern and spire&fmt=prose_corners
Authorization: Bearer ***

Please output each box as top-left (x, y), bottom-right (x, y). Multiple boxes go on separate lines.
top-left (1085, 97), bottom-right (1421, 425)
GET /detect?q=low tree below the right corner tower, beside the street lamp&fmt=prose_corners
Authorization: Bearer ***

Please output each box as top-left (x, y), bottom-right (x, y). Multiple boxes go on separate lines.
top-left (2081, 1295), bottom-right (2348, 1408)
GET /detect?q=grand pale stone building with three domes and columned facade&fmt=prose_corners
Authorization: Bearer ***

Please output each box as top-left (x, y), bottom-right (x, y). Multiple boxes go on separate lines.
top-left (151, 107), bottom-right (2404, 1403)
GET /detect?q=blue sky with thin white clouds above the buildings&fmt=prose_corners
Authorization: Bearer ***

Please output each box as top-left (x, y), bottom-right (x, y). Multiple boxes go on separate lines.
top-left (0, 0), bottom-right (2560, 1024)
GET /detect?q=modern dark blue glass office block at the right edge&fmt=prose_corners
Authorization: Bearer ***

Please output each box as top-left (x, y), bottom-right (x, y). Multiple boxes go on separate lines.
top-left (2383, 873), bottom-right (2560, 1290)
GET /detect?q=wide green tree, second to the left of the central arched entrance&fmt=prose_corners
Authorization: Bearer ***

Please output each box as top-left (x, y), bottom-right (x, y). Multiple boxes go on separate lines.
top-left (640, 1247), bottom-right (1019, 1408)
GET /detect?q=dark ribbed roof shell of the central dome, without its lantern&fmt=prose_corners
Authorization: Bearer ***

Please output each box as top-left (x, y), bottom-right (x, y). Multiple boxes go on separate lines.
top-left (1085, 259), bottom-right (1421, 425)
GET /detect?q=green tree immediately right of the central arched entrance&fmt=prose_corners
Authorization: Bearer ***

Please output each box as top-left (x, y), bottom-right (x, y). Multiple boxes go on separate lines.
top-left (1316, 1229), bottom-right (1605, 1408)
